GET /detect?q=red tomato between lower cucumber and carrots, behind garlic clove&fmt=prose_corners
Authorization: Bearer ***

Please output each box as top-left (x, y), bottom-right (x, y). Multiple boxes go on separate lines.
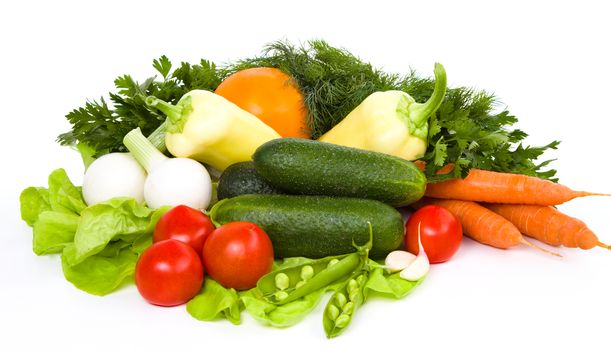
top-left (405, 205), bottom-right (462, 264)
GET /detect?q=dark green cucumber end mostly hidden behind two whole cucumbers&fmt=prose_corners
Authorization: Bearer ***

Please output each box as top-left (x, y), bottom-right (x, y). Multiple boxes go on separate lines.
top-left (217, 162), bottom-right (282, 200)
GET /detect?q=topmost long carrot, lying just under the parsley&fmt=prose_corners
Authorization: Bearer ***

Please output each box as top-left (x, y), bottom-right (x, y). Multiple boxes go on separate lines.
top-left (425, 169), bottom-right (608, 206)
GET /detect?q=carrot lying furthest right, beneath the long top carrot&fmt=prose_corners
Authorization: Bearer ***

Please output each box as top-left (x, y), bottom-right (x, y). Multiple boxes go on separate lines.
top-left (486, 204), bottom-right (611, 249)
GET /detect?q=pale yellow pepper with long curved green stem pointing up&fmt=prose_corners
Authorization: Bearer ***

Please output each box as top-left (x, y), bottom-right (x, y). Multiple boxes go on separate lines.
top-left (318, 63), bottom-right (446, 160)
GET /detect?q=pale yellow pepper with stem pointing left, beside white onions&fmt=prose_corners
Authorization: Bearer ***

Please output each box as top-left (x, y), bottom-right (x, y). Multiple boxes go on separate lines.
top-left (146, 90), bottom-right (280, 171)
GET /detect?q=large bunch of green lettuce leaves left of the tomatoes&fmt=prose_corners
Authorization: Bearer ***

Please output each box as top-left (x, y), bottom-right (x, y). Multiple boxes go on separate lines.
top-left (19, 169), bottom-right (169, 295)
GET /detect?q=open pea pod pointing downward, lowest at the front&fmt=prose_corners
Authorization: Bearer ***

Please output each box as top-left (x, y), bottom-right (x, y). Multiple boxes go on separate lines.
top-left (322, 270), bottom-right (369, 338)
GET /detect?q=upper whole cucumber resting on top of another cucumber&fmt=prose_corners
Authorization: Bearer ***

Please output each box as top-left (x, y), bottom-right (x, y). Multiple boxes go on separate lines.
top-left (253, 138), bottom-right (426, 207)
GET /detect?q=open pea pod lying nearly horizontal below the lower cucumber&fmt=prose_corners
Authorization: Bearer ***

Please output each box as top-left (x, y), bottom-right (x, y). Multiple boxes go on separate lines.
top-left (257, 253), bottom-right (362, 305)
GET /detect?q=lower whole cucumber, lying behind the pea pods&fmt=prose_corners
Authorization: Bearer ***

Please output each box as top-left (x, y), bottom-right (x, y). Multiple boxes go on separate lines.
top-left (210, 194), bottom-right (404, 258)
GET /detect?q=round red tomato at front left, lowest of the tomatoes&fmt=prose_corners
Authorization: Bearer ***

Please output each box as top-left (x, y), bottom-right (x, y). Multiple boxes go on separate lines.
top-left (136, 239), bottom-right (204, 306)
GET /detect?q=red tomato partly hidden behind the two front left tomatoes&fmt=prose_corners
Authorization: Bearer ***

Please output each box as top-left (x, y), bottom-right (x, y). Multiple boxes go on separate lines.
top-left (153, 205), bottom-right (214, 254)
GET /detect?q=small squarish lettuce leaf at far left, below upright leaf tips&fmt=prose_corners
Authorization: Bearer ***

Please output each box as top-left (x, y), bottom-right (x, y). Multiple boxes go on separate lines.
top-left (32, 211), bottom-right (80, 255)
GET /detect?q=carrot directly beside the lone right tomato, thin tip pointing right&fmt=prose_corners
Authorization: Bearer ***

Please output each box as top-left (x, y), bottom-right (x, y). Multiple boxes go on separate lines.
top-left (423, 199), bottom-right (558, 255)
